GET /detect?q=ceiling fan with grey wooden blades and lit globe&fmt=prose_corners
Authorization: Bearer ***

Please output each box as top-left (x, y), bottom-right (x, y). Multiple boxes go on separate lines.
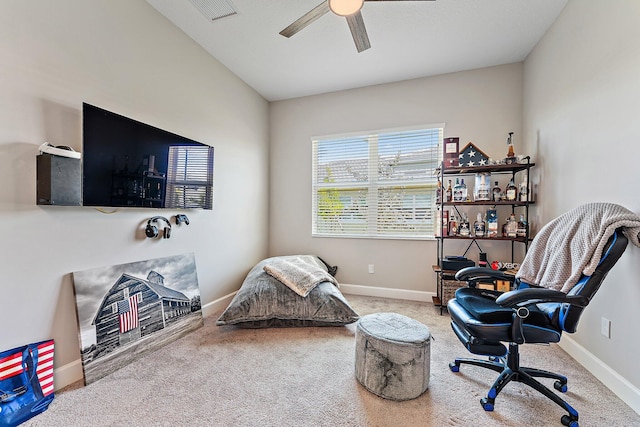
top-left (280, 0), bottom-right (435, 52)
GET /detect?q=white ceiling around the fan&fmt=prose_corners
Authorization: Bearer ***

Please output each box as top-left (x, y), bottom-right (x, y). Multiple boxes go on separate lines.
top-left (147, 0), bottom-right (568, 101)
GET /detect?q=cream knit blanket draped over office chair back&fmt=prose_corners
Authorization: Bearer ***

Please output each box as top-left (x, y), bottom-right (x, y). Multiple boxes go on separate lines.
top-left (516, 202), bottom-right (640, 293)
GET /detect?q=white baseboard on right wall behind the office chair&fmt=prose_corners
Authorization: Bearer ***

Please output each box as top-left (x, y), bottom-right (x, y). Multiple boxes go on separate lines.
top-left (558, 335), bottom-right (640, 414)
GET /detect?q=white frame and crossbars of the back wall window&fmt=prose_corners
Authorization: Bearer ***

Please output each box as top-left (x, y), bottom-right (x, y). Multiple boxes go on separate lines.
top-left (311, 123), bottom-right (445, 240)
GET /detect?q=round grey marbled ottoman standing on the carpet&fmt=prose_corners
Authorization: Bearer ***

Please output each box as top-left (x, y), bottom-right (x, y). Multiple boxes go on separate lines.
top-left (356, 313), bottom-right (431, 400)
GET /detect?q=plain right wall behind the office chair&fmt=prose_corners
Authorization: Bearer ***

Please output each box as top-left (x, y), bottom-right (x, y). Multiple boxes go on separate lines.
top-left (524, 0), bottom-right (640, 412)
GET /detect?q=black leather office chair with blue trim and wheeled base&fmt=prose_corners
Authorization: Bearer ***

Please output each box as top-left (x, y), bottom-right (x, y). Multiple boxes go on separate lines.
top-left (447, 229), bottom-right (628, 427)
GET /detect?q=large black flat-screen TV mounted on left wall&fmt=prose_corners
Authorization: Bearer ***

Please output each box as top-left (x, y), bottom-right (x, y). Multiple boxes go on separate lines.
top-left (82, 103), bottom-right (213, 209)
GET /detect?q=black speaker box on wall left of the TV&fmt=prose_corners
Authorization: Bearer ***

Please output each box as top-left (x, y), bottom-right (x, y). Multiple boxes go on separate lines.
top-left (36, 154), bottom-right (82, 206)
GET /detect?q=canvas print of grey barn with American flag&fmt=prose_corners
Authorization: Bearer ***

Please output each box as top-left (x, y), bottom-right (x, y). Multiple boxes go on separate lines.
top-left (73, 254), bottom-right (203, 384)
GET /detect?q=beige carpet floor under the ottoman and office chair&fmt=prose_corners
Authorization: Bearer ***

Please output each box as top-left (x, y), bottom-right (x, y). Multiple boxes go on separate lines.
top-left (25, 295), bottom-right (640, 427)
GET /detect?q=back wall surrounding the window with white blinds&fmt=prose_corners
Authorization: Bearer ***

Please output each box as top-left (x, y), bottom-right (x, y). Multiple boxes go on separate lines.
top-left (269, 63), bottom-right (522, 292)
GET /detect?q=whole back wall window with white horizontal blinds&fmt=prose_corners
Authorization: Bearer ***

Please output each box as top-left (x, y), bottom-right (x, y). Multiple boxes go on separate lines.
top-left (312, 125), bottom-right (444, 238)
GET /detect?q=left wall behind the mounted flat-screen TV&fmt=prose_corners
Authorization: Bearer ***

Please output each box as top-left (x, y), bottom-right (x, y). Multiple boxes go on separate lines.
top-left (0, 0), bottom-right (269, 386)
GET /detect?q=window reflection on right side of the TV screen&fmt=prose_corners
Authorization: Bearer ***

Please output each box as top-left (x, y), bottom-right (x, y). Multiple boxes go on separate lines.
top-left (166, 145), bottom-right (213, 209)
